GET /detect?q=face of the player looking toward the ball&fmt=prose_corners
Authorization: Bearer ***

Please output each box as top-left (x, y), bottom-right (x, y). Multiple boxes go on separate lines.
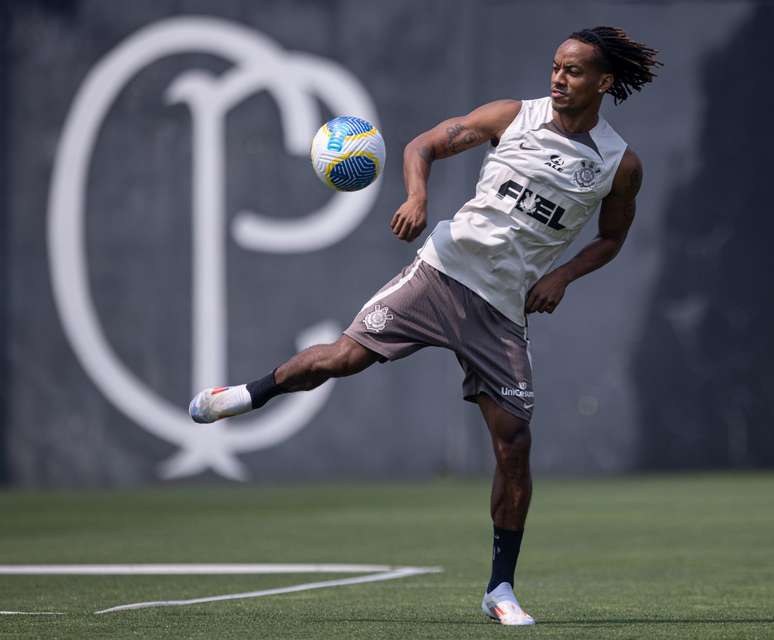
top-left (551, 40), bottom-right (613, 113)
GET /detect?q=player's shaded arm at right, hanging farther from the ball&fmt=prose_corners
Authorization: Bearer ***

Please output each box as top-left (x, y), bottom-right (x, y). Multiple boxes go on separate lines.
top-left (525, 149), bottom-right (642, 313)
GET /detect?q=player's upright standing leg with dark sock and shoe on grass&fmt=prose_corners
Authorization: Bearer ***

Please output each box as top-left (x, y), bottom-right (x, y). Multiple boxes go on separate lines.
top-left (478, 394), bottom-right (534, 625)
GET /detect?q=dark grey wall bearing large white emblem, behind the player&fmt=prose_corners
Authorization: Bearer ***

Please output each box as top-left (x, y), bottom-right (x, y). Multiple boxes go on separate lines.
top-left (0, 0), bottom-right (774, 487)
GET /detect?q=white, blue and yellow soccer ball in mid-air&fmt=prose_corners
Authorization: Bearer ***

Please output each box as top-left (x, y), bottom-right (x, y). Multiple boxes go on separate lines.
top-left (312, 116), bottom-right (386, 191)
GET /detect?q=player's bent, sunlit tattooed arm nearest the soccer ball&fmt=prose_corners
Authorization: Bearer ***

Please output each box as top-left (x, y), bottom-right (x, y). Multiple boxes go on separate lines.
top-left (390, 100), bottom-right (521, 242)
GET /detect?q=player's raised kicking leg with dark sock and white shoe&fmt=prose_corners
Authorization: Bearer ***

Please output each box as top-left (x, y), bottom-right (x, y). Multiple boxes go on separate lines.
top-left (189, 336), bottom-right (379, 423)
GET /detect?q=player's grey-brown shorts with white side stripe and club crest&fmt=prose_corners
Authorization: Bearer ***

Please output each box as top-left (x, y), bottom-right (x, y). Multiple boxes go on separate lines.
top-left (344, 258), bottom-right (535, 420)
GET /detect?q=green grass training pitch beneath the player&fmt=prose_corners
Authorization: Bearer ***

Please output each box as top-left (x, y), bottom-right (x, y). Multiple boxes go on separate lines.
top-left (0, 474), bottom-right (774, 640)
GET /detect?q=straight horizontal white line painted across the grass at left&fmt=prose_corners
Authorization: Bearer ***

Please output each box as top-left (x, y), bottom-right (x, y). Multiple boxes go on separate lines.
top-left (0, 563), bottom-right (399, 576)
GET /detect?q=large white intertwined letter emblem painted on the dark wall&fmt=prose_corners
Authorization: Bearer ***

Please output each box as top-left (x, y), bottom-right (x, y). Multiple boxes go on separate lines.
top-left (48, 17), bottom-right (379, 479)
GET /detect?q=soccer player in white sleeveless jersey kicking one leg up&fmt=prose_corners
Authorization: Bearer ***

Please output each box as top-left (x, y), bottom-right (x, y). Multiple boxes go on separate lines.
top-left (190, 27), bottom-right (660, 625)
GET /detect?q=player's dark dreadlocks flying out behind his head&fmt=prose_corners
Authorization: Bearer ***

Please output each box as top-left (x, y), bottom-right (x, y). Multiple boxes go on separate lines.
top-left (570, 27), bottom-right (662, 104)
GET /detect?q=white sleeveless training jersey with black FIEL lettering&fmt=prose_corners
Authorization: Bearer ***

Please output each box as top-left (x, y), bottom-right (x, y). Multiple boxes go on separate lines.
top-left (418, 97), bottom-right (626, 326)
